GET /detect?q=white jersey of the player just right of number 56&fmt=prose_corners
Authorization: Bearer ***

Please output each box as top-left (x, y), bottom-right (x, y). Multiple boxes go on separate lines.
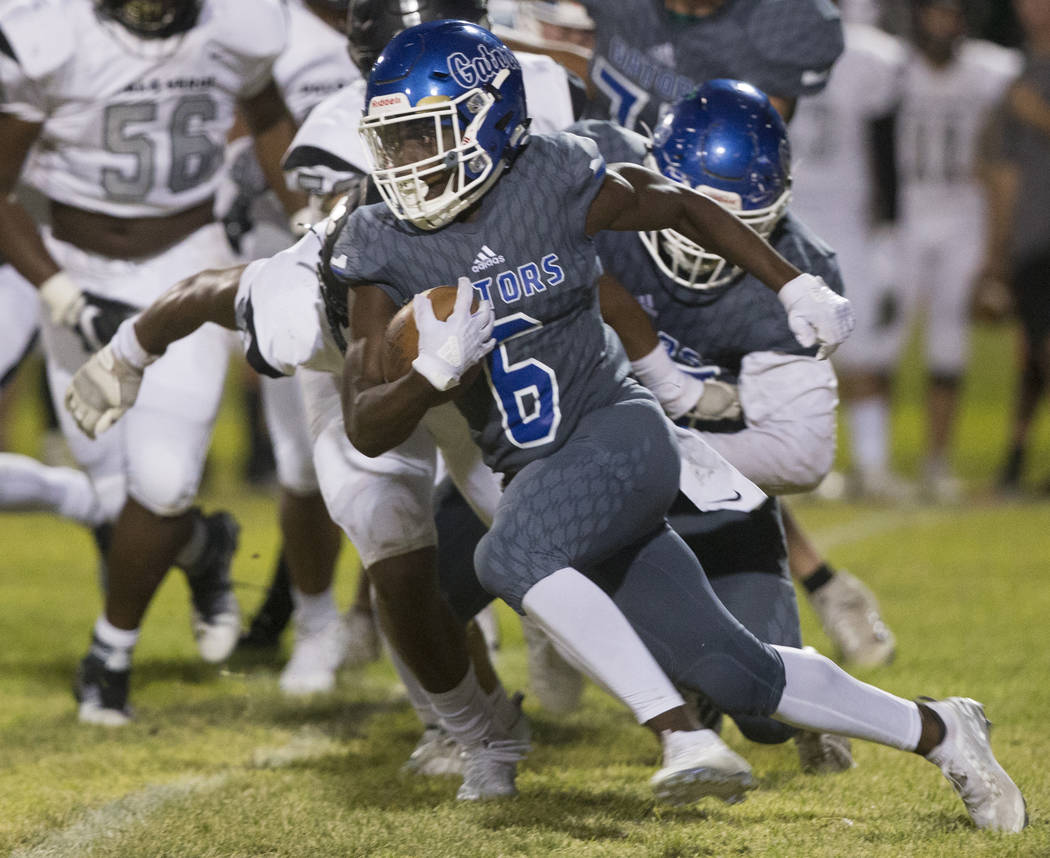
top-left (273, 0), bottom-right (361, 125)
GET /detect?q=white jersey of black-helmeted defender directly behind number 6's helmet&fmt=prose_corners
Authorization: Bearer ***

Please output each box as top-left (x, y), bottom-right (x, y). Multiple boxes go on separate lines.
top-left (285, 53), bottom-right (574, 196)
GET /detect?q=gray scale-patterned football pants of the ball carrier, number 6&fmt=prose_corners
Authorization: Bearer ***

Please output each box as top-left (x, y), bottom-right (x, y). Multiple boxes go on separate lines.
top-left (475, 399), bottom-right (784, 716)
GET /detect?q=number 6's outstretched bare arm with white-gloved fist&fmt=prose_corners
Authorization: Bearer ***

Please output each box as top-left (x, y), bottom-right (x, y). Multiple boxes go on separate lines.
top-left (585, 164), bottom-right (856, 357)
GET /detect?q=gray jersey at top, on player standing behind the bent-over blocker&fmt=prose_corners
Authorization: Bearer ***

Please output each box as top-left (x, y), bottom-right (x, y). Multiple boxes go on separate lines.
top-left (583, 0), bottom-right (843, 128)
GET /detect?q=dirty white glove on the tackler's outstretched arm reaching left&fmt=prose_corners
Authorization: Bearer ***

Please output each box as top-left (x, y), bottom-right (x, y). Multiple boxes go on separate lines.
top-left (65, 319), bottom-right (156, 438)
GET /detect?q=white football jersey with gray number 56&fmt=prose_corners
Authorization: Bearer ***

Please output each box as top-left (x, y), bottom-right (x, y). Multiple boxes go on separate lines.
top-left (0, 0), bottom-right (287, 217)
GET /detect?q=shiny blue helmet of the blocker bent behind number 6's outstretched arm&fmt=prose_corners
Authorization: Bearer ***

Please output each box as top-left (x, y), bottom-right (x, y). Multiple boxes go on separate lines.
top-left (641, 79), bottom-right (791, 290)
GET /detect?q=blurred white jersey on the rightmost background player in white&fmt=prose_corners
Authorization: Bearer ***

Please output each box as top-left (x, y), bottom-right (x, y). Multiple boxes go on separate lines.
top-left (897, 40), bottom-right (1022, 217)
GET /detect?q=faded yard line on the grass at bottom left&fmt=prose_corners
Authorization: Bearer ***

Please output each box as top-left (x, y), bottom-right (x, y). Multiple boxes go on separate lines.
top-left (11, 730), bottom-right (342, 858)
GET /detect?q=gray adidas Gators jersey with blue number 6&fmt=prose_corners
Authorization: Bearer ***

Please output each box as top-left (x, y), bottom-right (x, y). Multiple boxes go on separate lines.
top-left (330, 132), bottom-right (634, 473)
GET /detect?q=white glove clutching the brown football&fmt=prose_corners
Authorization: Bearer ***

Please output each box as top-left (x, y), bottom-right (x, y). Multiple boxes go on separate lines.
top-left (412, 277), bottom-right (496, 391)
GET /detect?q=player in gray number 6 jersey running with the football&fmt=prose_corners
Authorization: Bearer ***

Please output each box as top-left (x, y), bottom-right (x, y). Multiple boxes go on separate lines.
top-left (332, 21), bottom-right (1026, 831)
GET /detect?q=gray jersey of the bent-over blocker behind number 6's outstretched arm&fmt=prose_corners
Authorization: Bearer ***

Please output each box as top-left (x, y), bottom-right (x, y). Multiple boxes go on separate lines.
top-left (572, 121), bottom-right (842, 375)
